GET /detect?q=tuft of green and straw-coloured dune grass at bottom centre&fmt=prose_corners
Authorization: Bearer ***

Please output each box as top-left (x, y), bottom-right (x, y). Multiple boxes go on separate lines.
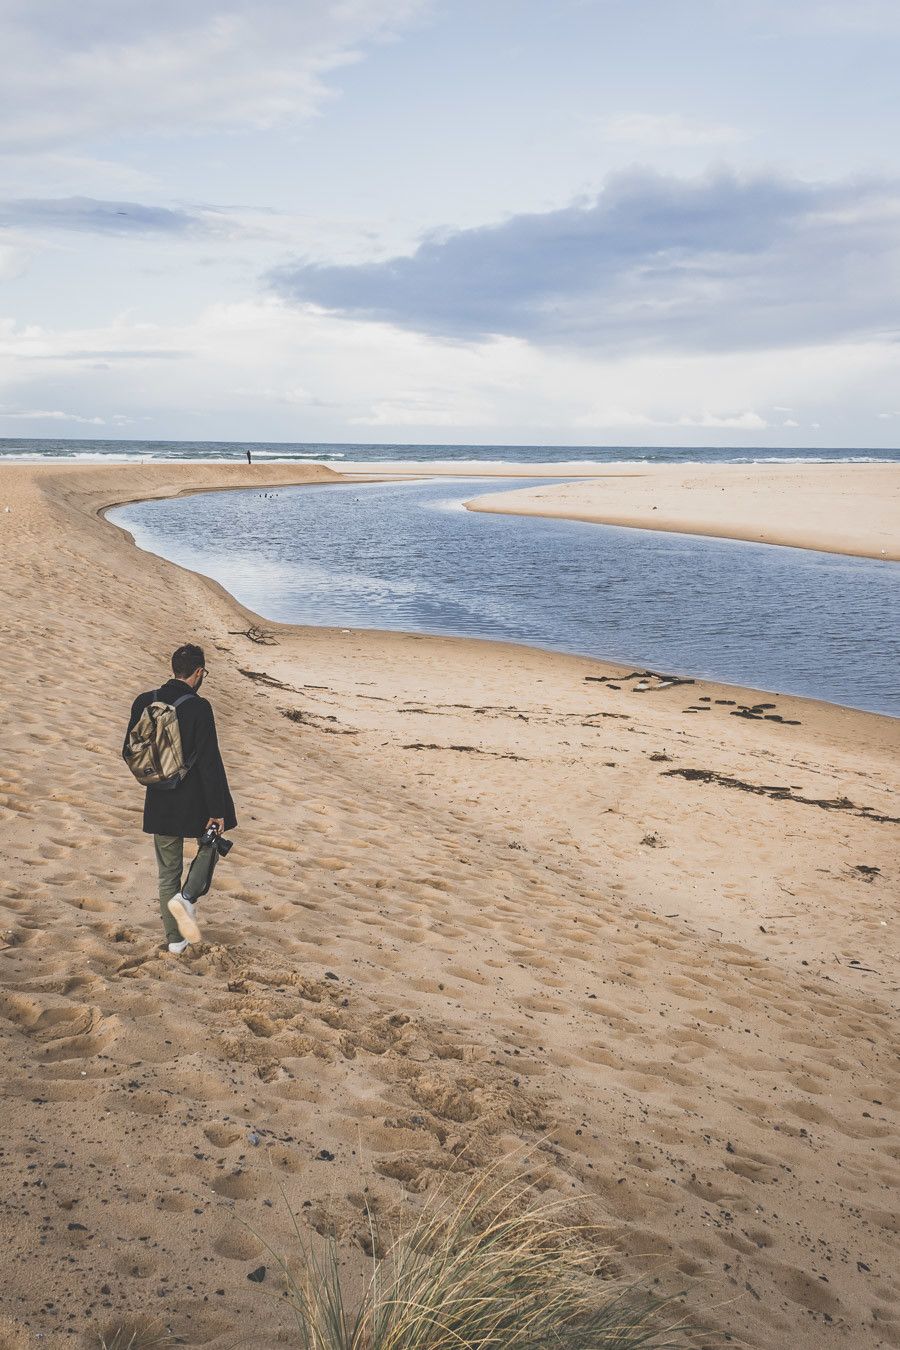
top-left (267, 1173), bottom-right (687, 1350)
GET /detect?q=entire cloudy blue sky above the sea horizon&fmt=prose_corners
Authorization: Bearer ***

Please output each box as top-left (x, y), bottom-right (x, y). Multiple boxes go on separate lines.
top-left (0, 0), bottom-right (900, 448)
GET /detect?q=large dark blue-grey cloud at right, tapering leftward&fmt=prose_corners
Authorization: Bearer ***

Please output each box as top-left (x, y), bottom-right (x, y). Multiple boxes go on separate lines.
top-left (270, 170), bottom-right (900, 351)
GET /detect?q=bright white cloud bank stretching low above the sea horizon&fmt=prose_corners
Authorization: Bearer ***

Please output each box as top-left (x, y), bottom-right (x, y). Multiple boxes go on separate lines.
top-left (0, 297), bottom-right (900, 445)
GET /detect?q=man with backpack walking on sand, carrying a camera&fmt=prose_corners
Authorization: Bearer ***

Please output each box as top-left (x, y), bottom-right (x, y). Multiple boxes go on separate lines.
top-left (121, 643), bottom-right (237, 956)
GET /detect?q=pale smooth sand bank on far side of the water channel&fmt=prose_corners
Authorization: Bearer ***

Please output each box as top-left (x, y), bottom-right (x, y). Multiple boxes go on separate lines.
top-left (470, 464), bottom-right (900, 563)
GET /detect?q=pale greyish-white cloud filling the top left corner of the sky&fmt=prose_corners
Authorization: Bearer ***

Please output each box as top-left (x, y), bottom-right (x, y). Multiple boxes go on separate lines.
top-left (0, 0), bottom-right (425, 151)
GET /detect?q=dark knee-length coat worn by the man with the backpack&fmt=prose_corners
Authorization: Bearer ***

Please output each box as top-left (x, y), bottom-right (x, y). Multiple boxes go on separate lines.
top-left (121, 679), bottom-right (237, 838)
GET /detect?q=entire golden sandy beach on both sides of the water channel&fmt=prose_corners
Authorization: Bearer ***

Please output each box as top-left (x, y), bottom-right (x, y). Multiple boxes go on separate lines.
top-left (0, 463), bottom-right (900, 1350)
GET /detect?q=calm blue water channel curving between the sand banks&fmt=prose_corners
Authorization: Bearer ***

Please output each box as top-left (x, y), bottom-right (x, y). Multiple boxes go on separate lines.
top-left (109, 479), bottom-right (900, 716)
